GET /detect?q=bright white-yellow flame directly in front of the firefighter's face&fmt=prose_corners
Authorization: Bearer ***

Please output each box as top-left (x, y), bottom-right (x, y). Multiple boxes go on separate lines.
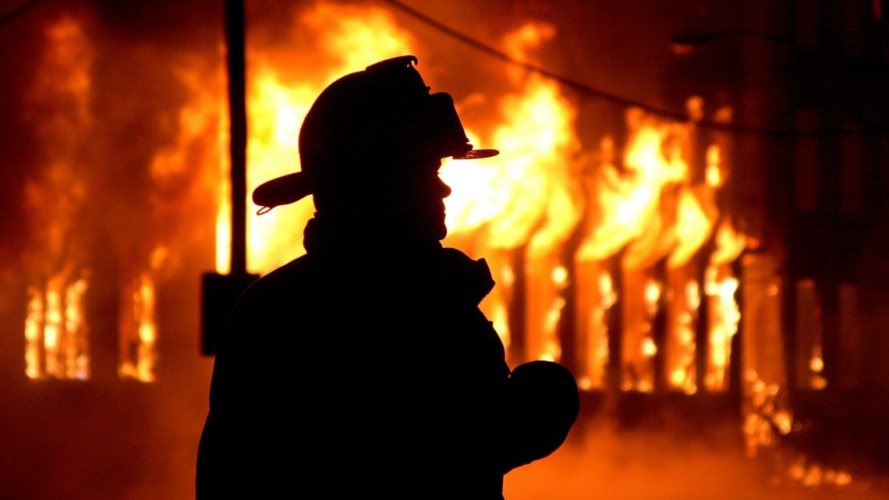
top-left (442, 23), bottom-right (580, 253)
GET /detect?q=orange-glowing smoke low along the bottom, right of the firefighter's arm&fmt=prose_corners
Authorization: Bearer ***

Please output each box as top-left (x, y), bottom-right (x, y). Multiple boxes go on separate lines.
top-left (504, 401), bottom-right (885, 500)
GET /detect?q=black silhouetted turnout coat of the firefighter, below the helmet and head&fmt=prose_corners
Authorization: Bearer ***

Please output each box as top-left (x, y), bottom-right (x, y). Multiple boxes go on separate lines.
top-left (197, 223), bottom-right (578, 500)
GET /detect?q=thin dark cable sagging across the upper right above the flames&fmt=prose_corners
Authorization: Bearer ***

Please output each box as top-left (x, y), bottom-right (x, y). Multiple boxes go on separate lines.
top-left (382, 0), bottom-right (887, 136)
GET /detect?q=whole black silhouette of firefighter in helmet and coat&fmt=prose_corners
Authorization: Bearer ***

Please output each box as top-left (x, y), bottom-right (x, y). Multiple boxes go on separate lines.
top-left (196, 56), bottom-right (578, 500)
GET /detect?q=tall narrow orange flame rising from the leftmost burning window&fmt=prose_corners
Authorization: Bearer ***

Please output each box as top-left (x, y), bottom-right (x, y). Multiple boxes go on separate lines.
top-left (25, 17), bottom-right (93, 379)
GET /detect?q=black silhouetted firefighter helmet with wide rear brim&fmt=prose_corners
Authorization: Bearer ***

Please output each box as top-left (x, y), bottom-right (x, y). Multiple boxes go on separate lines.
top-left (253, 56), bottom-right (498, 212)
